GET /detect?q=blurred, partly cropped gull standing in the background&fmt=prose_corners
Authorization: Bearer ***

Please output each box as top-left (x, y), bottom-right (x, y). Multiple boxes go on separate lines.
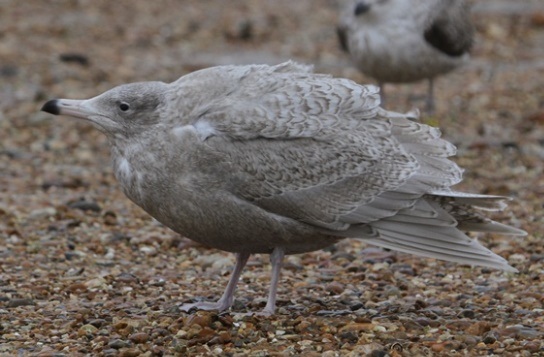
top-left (338, 0), bottom-right (474, 112)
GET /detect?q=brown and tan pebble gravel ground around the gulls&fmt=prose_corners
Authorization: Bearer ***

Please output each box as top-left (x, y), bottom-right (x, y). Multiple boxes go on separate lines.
top-left (0, 0), bottom-right (544, 357)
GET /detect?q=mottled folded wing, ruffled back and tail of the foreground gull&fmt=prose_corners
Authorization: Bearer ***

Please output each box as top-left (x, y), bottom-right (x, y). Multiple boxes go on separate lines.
top-left (174, 63), bottom-right (525, 270)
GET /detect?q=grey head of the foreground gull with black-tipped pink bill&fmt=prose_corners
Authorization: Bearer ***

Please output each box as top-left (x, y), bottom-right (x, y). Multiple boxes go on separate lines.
top-left (42, 82), bottom-right (167, 138)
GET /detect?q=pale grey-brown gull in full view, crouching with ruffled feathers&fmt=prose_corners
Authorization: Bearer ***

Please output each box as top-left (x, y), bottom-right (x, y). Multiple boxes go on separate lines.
top-left (42, 62), bottom-right (525, 314)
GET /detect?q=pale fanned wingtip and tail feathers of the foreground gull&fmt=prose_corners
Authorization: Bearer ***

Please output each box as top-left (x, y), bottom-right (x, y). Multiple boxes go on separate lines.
top-left (344, 195), bottom-right (526, 271)
